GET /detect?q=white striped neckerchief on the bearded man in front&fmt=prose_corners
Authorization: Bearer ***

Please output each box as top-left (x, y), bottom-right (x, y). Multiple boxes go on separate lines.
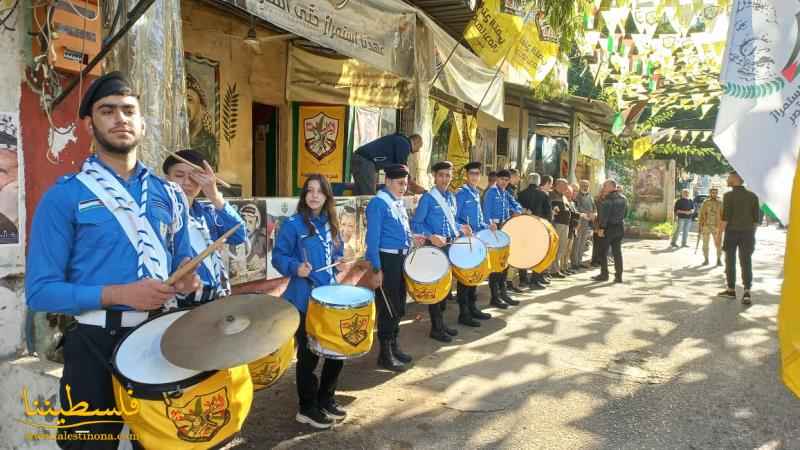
top-left (76, 156), bottom-right (170, 281)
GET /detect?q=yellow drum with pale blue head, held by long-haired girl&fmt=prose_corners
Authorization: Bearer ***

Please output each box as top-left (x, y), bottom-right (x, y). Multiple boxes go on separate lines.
top-left (306, 284), bottom-right (376, 359)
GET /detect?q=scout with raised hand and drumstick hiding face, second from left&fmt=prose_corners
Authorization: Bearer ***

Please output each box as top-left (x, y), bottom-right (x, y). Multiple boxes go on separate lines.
top-left (162, 150), bottom-right (247, 307)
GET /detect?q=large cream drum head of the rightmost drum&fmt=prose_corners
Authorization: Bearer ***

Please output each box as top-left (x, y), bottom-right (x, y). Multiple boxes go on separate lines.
top-left (503, 215), bottom-right (550, 269)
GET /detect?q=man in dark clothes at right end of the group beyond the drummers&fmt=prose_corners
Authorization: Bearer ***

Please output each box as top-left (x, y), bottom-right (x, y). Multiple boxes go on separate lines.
top-left (592, 180), bottom-right (628, 283)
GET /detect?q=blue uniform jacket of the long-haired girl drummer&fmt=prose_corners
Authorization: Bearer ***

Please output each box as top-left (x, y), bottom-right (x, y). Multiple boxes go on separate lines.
top-left (272, 214), bottom-right (344, 313)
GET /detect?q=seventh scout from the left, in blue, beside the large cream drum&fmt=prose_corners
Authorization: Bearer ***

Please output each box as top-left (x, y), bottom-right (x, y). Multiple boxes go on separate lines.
top-left (483, 170), bottom-right (522, 309)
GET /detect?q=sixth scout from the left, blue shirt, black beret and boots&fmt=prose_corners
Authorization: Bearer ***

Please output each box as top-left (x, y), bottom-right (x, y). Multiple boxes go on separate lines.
top-left (456, 161), bottom-right (497, 327)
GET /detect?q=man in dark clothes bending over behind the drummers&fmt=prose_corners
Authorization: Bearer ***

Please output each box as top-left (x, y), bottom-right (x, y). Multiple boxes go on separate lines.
top-left (350, 133), bottom-right (425, 195)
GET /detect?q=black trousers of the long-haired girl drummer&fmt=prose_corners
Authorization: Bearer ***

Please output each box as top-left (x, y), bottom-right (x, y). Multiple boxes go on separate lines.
top-left (295, 313), bottom-right (344, 411)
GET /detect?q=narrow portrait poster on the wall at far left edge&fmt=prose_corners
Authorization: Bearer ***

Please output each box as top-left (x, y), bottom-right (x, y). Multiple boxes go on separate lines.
top-left (0, 112), bottom-right (19, 244)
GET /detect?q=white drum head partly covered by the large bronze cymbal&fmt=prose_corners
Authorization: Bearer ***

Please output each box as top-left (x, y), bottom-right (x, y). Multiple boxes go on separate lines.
top-left (112, 309), bottom-right (214, 397)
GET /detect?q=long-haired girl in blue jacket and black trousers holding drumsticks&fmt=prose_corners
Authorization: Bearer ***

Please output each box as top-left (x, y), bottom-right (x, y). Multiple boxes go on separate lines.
top-left (272, 174), bottom-right (346, 428)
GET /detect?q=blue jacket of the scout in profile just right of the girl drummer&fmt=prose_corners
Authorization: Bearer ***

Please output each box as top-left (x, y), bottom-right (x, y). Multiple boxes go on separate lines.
top-left (366, 190), bottom-right (411, 269)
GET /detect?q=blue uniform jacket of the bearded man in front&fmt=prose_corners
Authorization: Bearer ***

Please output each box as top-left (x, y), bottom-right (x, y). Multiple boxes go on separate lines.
top-left (25, 160), bottom-right (192, 315)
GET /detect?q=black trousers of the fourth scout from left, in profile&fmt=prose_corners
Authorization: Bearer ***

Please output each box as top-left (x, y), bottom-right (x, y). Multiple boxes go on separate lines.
top-left (375, 252), bottom-right (406, 341)
